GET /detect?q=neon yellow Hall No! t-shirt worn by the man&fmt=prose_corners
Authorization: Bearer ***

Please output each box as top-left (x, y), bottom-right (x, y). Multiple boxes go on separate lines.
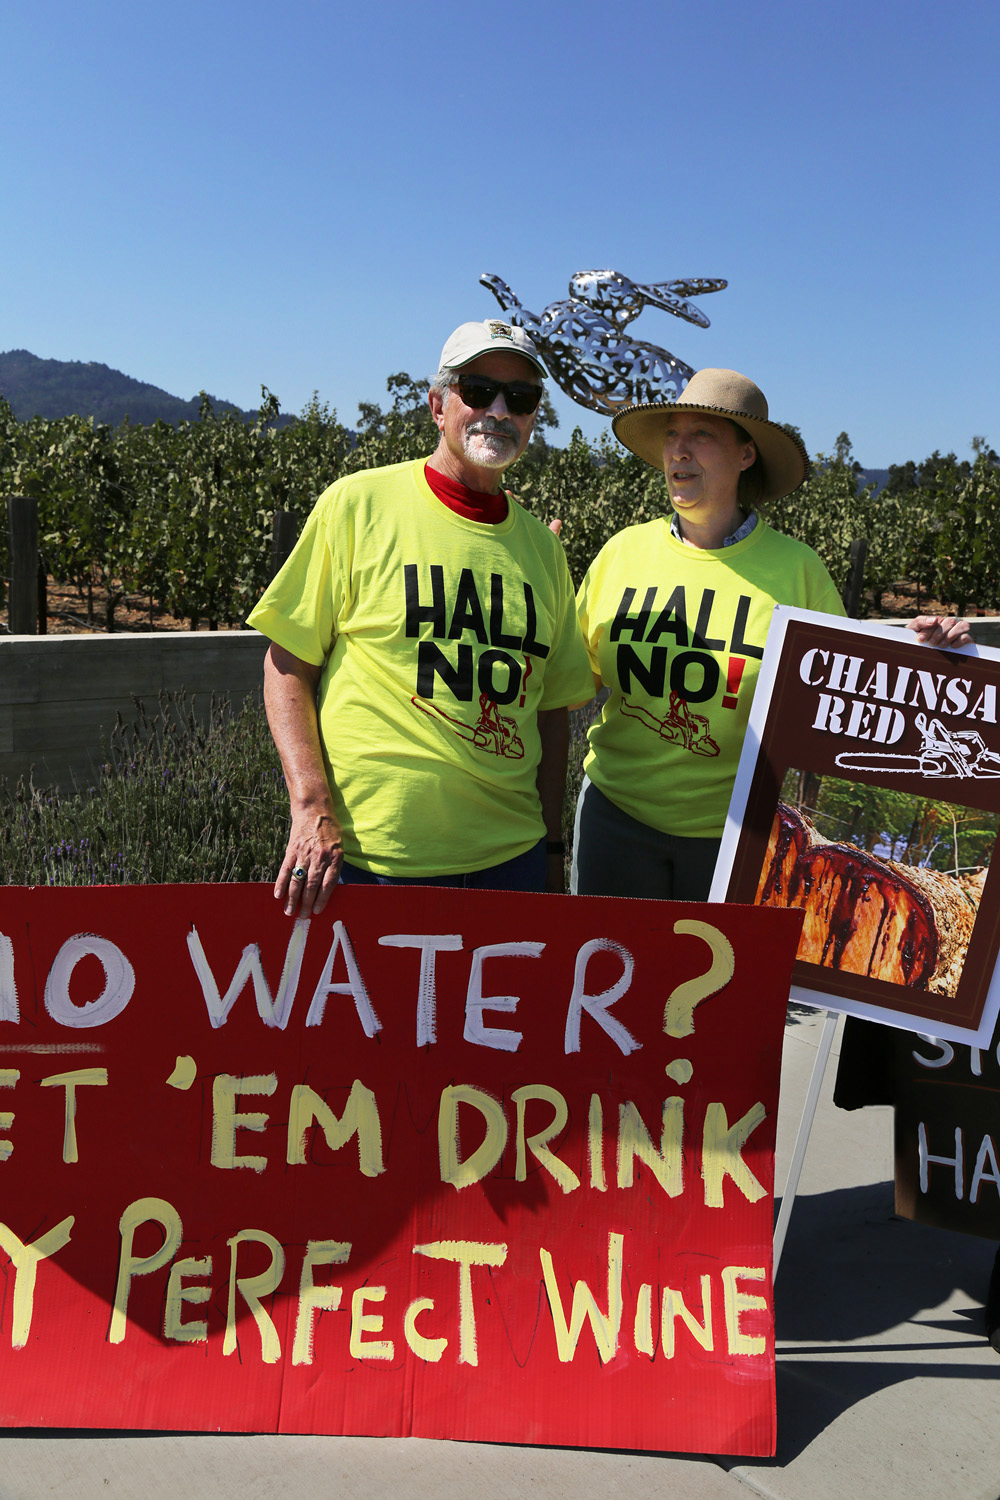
top-left (249, 459), bottom-right (592, 876)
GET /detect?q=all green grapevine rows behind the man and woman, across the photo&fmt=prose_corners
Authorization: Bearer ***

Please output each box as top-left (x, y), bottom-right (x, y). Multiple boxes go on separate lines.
top-left (0, 387), bottom-right (1000, 629)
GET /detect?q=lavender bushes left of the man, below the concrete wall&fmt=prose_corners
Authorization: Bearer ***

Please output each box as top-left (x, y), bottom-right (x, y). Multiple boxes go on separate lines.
top-left (0, 695), bottom-right (288, 885)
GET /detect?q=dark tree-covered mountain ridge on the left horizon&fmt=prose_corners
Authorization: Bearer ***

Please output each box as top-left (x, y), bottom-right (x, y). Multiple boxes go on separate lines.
top-left (0, 350), bottom-right (292, 428)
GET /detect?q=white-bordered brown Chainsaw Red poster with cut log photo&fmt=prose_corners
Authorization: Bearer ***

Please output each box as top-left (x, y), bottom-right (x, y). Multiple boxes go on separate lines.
top-left (712, 606), bottom-right (1000, 1044)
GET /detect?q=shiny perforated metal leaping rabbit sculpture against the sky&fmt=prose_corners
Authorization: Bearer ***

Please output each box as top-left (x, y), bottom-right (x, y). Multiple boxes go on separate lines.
top-left (480, 270), bottom-right (727, 414)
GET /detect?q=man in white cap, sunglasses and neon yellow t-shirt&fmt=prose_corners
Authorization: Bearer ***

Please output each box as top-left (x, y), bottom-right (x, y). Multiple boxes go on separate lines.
top-left (250, 320), bottom-right (592, 917)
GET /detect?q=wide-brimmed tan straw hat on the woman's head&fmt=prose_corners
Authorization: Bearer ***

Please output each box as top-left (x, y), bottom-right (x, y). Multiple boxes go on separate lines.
top-left (612, 369), bottom-right (810, 500)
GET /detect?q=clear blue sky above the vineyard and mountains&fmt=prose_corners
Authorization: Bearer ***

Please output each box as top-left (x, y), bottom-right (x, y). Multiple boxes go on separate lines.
top-left (0, 0), bottom-right (1000, 467)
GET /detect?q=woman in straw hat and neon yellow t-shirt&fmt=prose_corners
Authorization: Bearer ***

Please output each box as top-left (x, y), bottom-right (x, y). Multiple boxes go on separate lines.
top-left (573, 369), bottom-right (969, 900)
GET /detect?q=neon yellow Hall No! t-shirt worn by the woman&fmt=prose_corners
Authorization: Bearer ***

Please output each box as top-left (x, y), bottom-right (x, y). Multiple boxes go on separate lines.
top-left (577, 519), bottom-right (844, 839)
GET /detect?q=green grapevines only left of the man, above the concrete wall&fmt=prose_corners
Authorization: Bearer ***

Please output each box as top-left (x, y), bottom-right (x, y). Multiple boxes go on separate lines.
top-left (0, 389), bottom-right (355, 630)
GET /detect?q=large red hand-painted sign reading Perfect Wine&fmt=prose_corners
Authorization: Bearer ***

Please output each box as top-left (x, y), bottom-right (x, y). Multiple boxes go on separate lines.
top-left (0, 885), bottom-right (799, 1454)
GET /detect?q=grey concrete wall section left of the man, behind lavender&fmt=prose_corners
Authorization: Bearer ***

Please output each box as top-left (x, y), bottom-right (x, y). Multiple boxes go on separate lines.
top-left (0, 630), bottom-right (267, 791)
